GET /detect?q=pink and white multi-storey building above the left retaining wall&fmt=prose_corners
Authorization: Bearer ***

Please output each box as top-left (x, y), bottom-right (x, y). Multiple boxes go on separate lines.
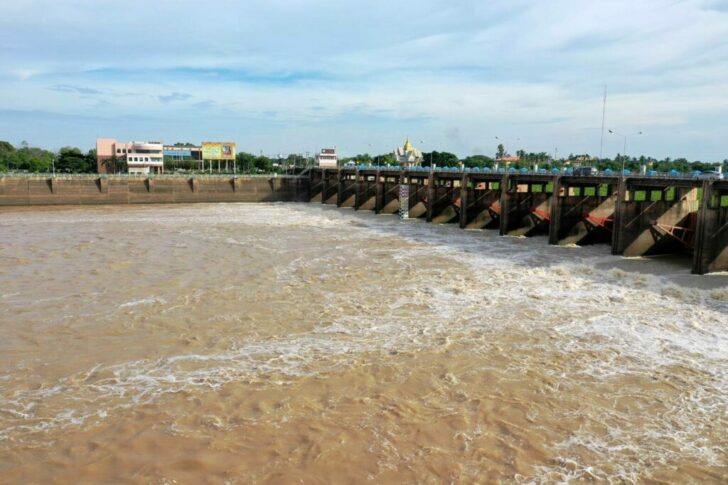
top-left (96, 138), bottom-right (164, 174)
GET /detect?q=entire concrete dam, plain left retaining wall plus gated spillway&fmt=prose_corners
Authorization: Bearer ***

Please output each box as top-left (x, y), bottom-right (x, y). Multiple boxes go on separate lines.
top-left (0, 167), bottom-right (728, 274)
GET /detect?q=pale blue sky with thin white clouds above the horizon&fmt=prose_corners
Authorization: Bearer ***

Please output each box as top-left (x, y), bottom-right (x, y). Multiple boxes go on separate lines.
top-left (0, 0), bottom-right (728, 161)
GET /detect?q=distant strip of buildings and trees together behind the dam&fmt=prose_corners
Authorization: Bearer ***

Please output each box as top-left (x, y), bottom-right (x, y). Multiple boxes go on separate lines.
top-left (0, 138), bottom-right (728, 174)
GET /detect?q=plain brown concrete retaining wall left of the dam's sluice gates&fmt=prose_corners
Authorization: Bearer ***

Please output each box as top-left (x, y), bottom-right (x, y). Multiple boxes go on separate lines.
top-left (0, 175), bottom-right (309, 207)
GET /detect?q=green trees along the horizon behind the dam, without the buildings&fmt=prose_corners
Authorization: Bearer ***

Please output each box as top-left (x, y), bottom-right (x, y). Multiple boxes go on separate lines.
top-left (0, 141), bottom-right (728, 173)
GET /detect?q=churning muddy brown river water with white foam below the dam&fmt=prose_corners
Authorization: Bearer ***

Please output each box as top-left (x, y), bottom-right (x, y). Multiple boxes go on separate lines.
top-left (0, 204), bottom-right (728, 484)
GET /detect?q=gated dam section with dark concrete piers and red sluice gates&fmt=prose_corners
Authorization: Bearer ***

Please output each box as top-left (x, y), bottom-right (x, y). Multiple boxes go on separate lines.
top-left (308, 167), bottom-right (728, 274)
